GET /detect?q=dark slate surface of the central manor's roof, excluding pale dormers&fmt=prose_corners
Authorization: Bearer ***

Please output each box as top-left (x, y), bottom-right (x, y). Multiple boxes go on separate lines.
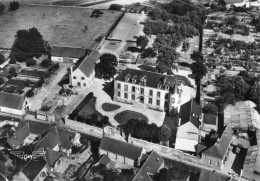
top-left (115, 68), bottom-right (182, 89)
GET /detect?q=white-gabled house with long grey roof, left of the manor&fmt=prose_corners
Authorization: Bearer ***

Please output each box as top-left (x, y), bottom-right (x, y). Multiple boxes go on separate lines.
top-left (70, 50), bottom-right (100, 88)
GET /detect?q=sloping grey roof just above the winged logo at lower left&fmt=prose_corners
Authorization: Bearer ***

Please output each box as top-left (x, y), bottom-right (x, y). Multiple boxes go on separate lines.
top-left (7, 124), bottom-right (30, 148)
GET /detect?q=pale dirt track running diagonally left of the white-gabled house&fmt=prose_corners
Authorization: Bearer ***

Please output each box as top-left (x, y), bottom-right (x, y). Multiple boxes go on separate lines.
top-left (31, 63), bottom-right (72, 111)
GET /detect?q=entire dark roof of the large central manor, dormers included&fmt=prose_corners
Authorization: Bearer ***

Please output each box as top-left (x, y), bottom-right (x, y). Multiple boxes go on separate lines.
top-left (115, 68), bottom-right (183, 89)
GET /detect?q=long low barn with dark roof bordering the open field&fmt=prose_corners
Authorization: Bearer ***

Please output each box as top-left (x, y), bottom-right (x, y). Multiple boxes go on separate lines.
top-left (51, 46), bottom-right (87, 63)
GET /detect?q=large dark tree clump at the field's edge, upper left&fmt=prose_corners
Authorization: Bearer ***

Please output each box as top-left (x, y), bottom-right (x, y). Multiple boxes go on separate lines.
top-left (10, 28), bottom-right (50, 62)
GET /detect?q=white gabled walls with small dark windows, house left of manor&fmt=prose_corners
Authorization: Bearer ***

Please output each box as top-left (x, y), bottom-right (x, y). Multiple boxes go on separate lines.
top-left (70, 68), bottom-right (95, 88)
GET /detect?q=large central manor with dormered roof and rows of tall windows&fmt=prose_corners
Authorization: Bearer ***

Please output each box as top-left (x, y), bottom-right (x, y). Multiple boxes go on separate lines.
top-left (114, 68), bottom-right (183, 113)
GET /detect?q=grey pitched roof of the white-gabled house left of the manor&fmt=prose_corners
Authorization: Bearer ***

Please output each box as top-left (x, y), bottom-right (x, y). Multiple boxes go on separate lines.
top-left (78, 50), bottom-right (100, 76)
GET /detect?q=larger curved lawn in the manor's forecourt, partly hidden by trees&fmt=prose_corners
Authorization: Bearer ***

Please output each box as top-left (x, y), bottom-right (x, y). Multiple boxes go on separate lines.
top-left (114, 111), bottom-right (148, 125)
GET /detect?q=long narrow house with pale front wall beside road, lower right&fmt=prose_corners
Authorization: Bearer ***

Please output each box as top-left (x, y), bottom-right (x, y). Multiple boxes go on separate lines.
top-left (201, 125), bottom-right (234, 169)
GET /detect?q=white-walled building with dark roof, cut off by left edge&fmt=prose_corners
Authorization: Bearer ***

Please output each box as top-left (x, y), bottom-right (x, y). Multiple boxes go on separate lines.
top-left (0, 92), bottom-right (30, 116)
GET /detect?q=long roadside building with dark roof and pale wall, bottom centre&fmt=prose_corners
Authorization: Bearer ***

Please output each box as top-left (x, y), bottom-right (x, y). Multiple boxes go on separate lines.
top-left (99, 136), bottom-right (144, 167)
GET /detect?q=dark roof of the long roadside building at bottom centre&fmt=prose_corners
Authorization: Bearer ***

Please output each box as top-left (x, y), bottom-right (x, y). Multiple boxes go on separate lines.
top-left (99, 136), bottom-right (143, 160)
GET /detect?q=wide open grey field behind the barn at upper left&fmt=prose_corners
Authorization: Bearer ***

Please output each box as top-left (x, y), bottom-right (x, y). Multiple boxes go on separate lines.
top-left (0, 5), bottom-right (121, 49)
